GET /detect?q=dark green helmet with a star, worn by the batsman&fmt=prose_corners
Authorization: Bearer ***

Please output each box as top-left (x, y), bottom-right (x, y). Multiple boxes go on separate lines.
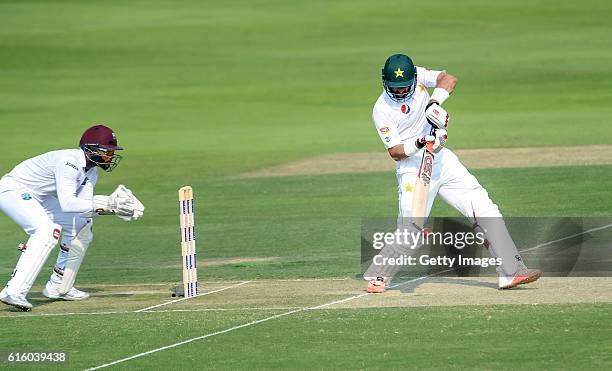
top-left (382, 54), bottom-right (417, 102)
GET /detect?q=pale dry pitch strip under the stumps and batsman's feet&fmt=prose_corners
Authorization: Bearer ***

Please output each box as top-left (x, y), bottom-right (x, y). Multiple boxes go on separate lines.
top-left (0, 277), bottom-right (612, 317)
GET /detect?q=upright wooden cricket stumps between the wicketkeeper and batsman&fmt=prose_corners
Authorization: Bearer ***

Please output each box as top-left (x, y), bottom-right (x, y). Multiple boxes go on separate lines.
top-left (179, 186), bottom-right (198, 298)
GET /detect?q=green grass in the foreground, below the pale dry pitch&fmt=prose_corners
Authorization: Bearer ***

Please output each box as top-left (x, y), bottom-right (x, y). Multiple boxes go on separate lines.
top-left (5, 304), bottom-right (612, 369)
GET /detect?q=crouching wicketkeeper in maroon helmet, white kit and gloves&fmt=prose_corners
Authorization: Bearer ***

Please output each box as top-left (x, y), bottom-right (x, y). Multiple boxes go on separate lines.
top-left (0, 125), bottom-right (144, 311)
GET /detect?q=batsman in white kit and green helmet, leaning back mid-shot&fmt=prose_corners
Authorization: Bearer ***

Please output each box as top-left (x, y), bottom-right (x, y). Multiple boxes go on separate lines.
top-left (364, 54), bottom-right (542, 293)
